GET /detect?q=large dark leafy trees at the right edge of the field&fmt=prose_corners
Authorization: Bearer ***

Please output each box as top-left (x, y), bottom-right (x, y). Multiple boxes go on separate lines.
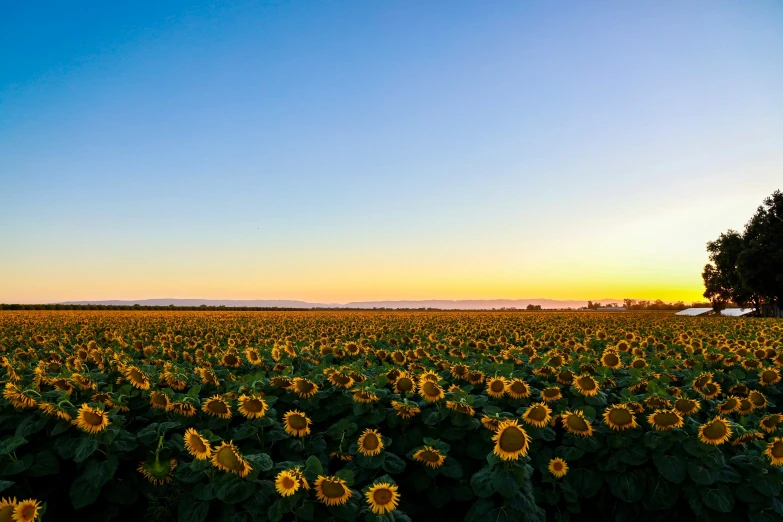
top-left (702, 190), bottom-right (783, 317)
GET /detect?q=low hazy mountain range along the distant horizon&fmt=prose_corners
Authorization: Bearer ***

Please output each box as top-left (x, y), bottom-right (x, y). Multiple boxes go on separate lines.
top-left (58, 299), bottom-right (623, 310)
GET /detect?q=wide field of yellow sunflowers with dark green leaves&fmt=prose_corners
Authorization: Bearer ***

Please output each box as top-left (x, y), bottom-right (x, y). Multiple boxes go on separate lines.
top-left (0, 311), bottom-right (783, 522)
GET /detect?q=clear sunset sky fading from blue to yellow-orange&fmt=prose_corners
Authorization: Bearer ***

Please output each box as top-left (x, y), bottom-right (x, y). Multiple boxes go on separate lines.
top-left (0, 0), bottom-right (783, 303)
